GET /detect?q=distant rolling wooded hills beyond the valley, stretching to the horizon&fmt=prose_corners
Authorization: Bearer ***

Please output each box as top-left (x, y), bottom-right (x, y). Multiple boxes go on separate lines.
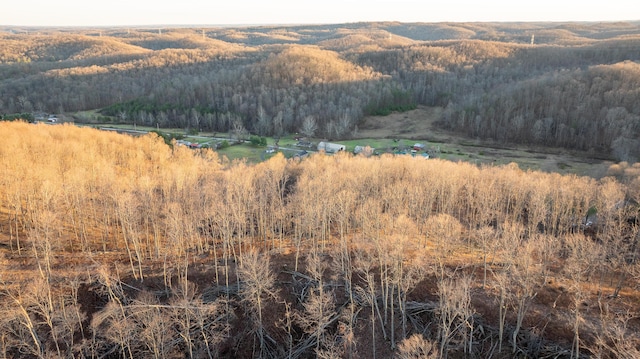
top-left (0, 22), bottom-right (640, 161)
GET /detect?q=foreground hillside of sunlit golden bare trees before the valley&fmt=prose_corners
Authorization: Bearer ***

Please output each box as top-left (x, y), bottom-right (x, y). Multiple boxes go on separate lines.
top-left (0, 122), bottom-right (640, 358)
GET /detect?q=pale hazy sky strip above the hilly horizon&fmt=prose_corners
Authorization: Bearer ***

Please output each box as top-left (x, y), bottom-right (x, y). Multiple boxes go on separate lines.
top-left (0, 0), bottom-right (640, 26)
